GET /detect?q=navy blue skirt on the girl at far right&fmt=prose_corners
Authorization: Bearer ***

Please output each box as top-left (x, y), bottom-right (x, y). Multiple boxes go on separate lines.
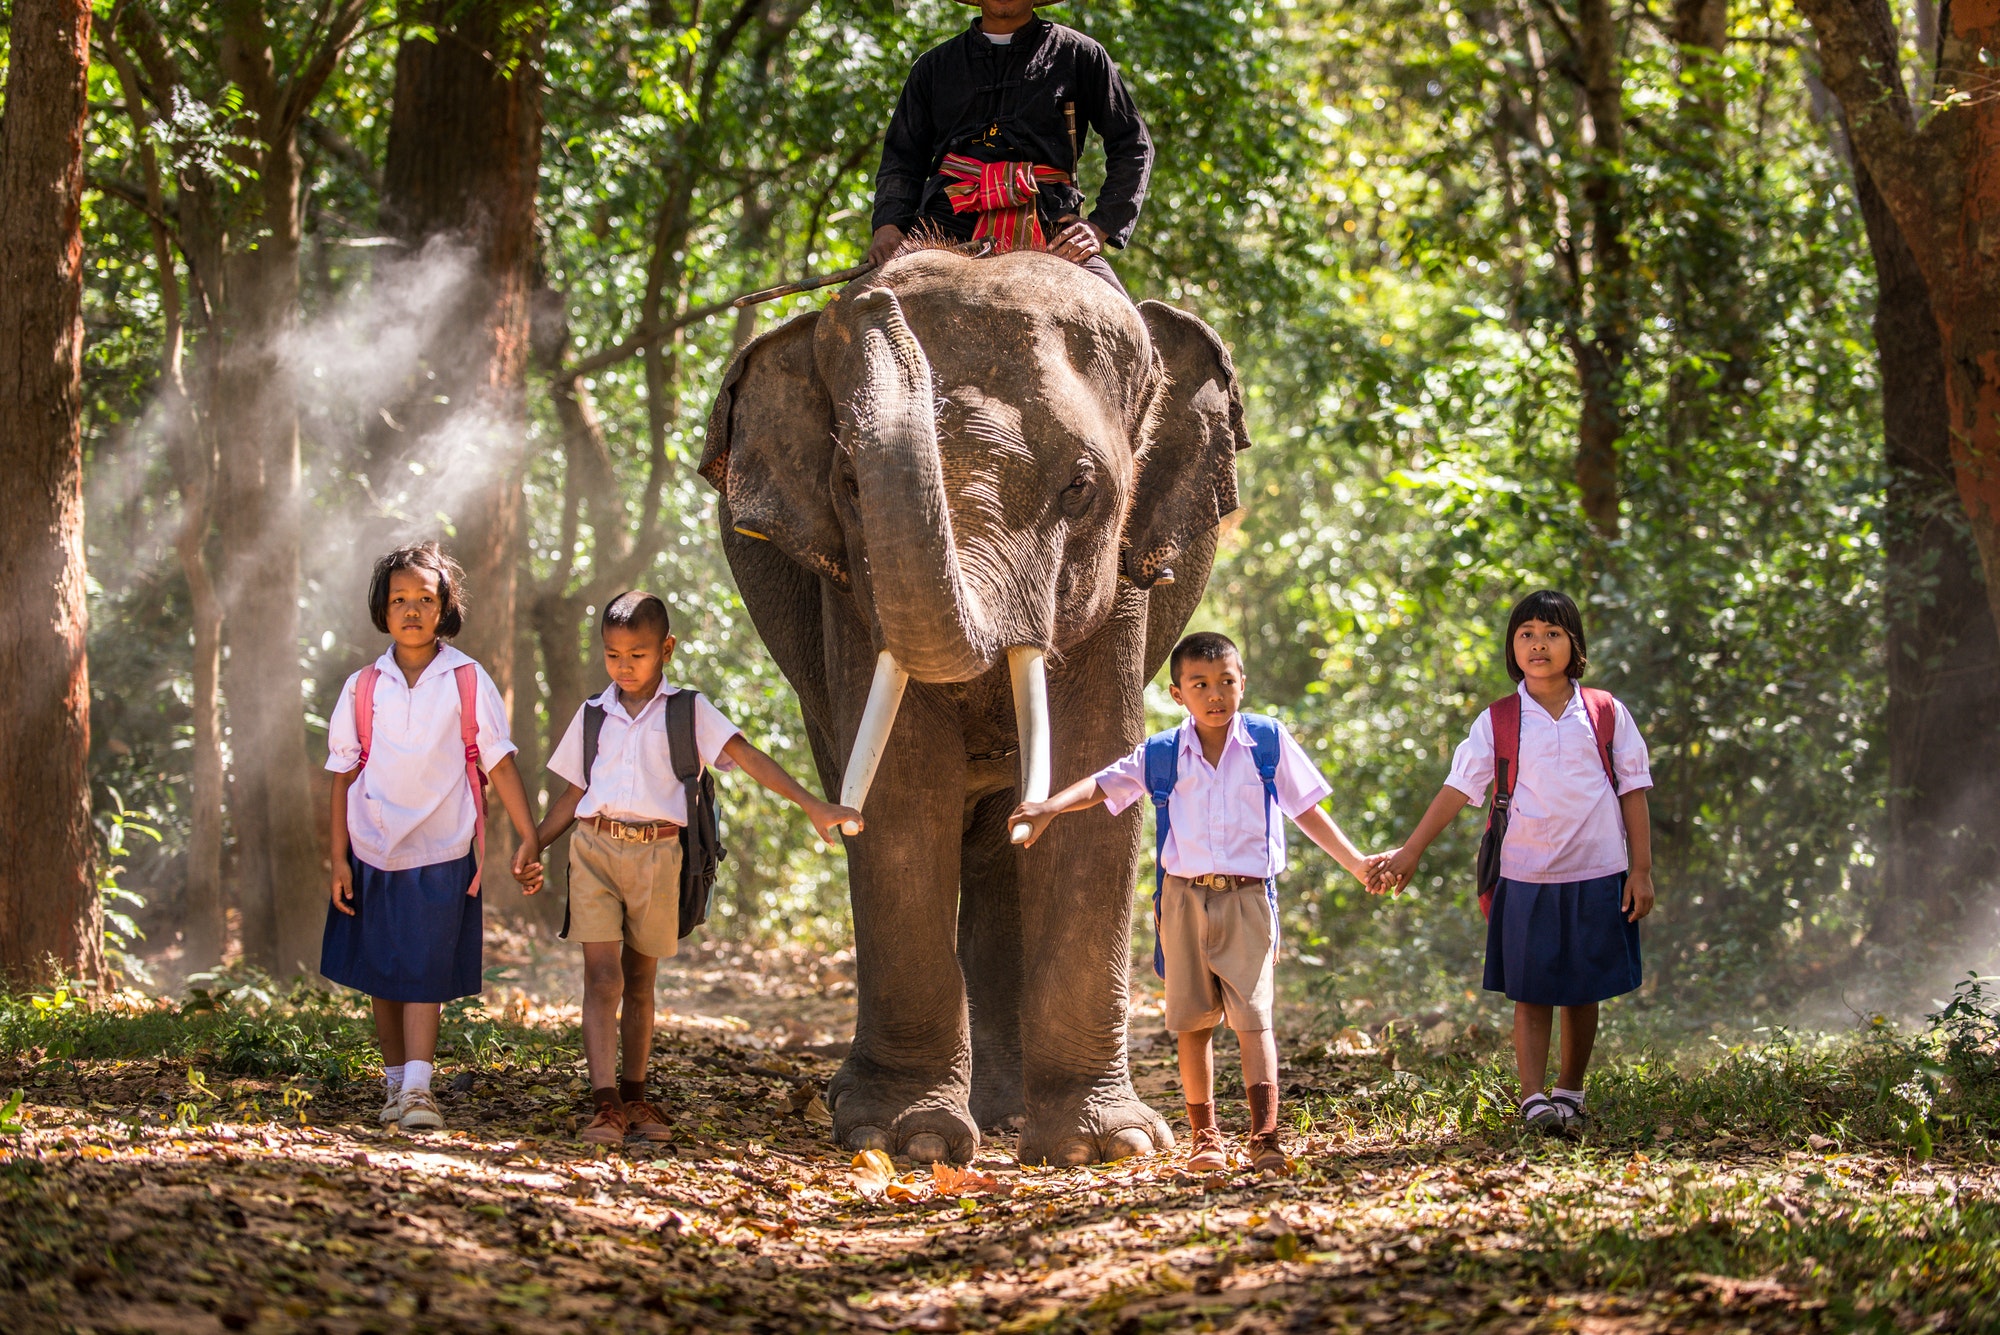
top-left (1486, 871), bottom-right (1640, 1005)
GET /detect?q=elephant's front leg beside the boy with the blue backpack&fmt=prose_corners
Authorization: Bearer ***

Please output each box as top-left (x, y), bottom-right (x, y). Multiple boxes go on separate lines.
top-left (1020, 586), bottom-right (1174, 1163)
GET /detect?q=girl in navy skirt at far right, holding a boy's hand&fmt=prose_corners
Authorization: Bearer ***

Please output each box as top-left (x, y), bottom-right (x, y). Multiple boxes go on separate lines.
top-left (1370, 590), bottom-right (1654, 1131)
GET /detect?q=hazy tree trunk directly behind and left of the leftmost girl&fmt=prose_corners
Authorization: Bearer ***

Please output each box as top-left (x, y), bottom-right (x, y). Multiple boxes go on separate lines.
top-left (210, 13), bottom-right (324, 977)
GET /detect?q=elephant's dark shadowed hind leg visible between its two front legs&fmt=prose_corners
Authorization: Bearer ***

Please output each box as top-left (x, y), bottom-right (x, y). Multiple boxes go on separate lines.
top-left (958, 787), bottom-right (1022, 1129)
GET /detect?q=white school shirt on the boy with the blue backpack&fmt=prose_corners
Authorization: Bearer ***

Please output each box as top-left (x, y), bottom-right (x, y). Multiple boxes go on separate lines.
top-left (1098, 713), bottom-right (1334, 879)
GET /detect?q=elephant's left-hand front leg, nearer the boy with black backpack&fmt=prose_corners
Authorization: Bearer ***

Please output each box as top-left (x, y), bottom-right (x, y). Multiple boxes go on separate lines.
top-left (828, 631), bottom-right (980, 1163)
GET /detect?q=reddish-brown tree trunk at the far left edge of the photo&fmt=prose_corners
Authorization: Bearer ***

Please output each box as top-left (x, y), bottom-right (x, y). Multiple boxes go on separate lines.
top-left (0, 0), bottom-right (104, 985)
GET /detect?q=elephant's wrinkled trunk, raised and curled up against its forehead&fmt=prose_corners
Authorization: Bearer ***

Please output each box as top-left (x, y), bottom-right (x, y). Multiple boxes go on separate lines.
top-left (848, 288), bottom-right (1004, 681)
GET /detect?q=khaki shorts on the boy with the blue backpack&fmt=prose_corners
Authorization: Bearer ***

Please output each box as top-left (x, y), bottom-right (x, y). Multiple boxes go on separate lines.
top-left (1160, 875), bottom-right (1276, 1033)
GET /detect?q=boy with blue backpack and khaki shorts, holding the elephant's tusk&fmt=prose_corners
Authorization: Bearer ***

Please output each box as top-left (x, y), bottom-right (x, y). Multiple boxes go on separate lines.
top-left (1008, 632), bottom-right (1368, 1173)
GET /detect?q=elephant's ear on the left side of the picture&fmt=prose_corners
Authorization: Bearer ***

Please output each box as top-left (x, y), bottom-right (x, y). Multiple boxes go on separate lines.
top-left (702, 312), bottom-right (848, 584)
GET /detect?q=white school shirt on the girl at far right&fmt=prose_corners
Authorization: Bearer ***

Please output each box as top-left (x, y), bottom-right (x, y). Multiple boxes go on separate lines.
top-left (1444, 683), bottom-right (1652, 885)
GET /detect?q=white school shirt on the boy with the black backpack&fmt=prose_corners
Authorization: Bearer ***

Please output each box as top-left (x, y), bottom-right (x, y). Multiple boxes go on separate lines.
top-left (548, 681), bottom-right (742, 825)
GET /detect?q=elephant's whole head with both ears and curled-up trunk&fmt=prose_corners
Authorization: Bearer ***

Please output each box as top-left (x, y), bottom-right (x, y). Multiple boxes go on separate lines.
top-left (702, 250), bottom-right (1248, 807)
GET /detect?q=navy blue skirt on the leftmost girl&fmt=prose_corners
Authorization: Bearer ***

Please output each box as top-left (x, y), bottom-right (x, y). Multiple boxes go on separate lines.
top-left (320, 849), bottom-right (486, 1001)
